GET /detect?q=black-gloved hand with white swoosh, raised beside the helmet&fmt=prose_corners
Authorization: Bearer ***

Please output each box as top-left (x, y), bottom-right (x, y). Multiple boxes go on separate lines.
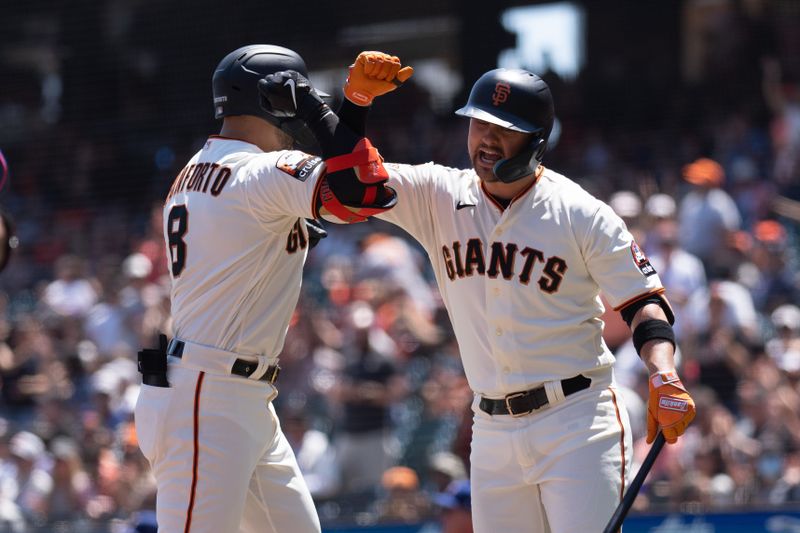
top-left (258, 70), bottom-right (327, 118)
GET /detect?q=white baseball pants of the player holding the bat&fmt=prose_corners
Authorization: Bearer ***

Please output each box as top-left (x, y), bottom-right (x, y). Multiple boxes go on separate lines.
top-left (470, 369), bottom-right (632, 533)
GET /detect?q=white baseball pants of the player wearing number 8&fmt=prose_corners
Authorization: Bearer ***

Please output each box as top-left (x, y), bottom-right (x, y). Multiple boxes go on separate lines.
top-left (135, 361), bottom-right (320, 533)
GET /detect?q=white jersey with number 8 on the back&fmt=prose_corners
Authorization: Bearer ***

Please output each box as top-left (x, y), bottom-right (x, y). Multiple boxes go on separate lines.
top-left (164, 136), bottom-right (323, 356)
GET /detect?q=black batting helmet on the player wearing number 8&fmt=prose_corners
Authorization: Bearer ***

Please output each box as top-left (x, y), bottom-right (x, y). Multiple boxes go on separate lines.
top-left (211, 44), bottom-right (328, 147)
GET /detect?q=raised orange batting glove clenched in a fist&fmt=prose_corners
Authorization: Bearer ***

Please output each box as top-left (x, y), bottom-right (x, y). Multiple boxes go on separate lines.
top-left (344, 52), bottom-right (414, 106)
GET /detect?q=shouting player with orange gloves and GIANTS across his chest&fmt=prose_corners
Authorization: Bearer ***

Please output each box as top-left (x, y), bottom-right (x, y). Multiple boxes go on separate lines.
top-left (330, 52), bottom-right (695, 533)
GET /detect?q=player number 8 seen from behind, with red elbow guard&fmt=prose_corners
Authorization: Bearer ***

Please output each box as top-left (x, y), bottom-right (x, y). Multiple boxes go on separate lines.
top-left (135, 45), bottom-right (404, 533)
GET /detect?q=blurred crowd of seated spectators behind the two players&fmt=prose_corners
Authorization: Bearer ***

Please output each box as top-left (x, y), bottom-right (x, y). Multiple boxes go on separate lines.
top-left (0, 0), bottom-right (800, 533)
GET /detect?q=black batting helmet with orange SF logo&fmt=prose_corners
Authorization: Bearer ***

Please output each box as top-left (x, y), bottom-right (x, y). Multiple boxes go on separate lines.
top-left (456, 68), bottom-right (555, 182)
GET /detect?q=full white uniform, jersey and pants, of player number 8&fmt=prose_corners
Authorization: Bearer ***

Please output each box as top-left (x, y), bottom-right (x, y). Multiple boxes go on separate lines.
top-left (135, 136), bottom-right (323, 533)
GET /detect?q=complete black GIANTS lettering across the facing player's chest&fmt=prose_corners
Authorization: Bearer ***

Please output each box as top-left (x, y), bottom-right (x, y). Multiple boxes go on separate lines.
top-left (442, 238), bottom-right (568, 294)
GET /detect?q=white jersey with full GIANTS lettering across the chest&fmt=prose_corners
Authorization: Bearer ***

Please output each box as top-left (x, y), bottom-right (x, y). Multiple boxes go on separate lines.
top-left (380, 163), bottom-right (663, 398)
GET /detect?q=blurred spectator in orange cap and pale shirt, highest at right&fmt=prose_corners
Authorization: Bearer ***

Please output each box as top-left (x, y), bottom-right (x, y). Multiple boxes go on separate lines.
top-left (678, 158), bottom-right (741, 277)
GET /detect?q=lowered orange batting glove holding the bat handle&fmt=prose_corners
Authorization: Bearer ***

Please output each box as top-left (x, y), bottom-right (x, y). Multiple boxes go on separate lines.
top-left (647, 370), bottom-right (695, 444)
